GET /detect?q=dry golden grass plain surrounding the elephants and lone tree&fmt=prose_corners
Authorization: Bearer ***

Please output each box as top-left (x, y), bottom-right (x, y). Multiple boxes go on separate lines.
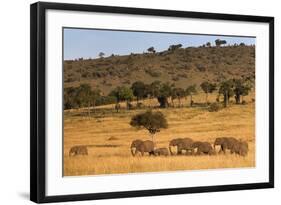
top-left (64, 91), bottom-right (255, 176)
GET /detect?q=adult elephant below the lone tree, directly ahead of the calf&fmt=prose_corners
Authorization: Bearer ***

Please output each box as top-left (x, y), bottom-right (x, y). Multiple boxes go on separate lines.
top-left (131, 140), bottom-right (154, 156)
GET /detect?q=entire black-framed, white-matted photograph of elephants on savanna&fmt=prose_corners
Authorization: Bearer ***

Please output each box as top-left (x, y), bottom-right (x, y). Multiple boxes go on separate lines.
top-left (30, 2), bottom-right (274, 203)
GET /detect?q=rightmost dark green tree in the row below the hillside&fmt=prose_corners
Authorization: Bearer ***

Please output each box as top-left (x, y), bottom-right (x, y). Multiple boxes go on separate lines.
top-left (233, 79), bottom-right (251, 104)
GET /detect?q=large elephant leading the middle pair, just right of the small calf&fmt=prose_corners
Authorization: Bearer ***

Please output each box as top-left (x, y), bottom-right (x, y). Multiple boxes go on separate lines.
top-left (169, 138), bottom-right (194, 155)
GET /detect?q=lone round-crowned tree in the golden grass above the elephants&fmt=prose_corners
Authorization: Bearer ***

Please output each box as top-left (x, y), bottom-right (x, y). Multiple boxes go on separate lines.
top-left (130, 110), bottom-right (168, 142)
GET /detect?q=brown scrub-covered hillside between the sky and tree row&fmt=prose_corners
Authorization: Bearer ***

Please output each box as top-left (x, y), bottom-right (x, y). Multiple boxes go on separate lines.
top-left (64, 46), bottom-right (255, 94)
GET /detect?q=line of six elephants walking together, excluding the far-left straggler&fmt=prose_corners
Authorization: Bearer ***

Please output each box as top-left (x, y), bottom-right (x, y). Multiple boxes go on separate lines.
top-left (131, 137), bottom-right (249, 156)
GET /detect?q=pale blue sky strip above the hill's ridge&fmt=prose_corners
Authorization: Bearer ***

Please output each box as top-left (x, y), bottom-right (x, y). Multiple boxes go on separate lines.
top-left (64, 28), bottom-right (255, 60)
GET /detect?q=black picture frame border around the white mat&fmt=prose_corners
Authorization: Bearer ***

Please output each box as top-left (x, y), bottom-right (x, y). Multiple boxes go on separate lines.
top-left (30, 2), bottom-right (274, 203)
